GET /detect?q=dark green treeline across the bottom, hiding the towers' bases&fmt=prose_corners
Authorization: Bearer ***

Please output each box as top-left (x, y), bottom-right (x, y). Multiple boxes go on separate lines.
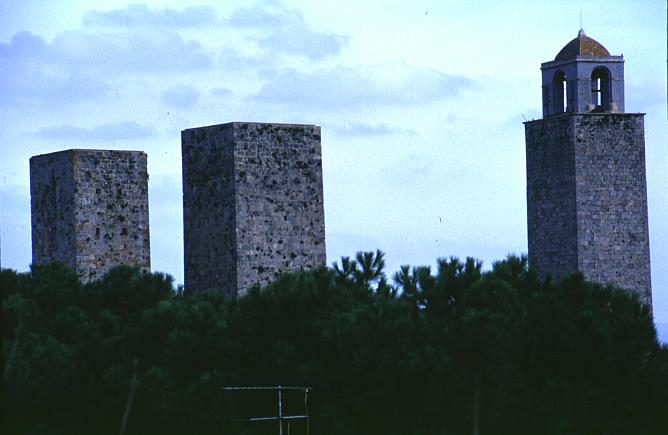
top-left (0, 252), bottom-right (668, 435)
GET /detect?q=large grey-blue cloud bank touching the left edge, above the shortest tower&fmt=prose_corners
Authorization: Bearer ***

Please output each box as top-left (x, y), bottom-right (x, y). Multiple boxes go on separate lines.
top-left (0, 30), bottom-right (213, 107)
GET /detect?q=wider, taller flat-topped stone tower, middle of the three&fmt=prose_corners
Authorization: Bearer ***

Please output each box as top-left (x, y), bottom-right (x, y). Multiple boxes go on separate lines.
top-left (181, 122), bottom-right (325, 297)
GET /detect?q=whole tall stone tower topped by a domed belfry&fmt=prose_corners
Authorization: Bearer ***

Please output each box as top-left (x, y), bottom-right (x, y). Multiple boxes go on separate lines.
top-left (524, 30), bottom-right (652, 307)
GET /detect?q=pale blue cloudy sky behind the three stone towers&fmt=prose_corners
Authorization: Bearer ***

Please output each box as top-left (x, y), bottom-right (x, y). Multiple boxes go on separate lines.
top-left (0, 0), bottom-right (668, 322)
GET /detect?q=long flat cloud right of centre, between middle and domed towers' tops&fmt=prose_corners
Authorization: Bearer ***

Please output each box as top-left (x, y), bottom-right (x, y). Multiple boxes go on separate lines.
top-left (251, 61), bottom-right (476, 109)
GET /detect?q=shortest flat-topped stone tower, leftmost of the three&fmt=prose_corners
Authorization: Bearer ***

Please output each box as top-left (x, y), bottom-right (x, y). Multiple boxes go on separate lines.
top-left (30, 150), bottom-right (151, 282)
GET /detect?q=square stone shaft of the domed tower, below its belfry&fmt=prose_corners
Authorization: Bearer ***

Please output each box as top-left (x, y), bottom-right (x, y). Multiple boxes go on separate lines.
top-left (525, 113), bottom-right (652, 307)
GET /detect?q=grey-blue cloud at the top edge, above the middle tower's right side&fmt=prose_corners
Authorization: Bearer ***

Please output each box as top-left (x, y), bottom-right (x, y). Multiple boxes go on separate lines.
top-left (224, 2), bottom-right (348, 60)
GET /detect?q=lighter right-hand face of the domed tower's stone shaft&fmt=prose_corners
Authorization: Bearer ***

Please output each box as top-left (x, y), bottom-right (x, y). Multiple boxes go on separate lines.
top-left (574, 114), bottom-right (652, 307)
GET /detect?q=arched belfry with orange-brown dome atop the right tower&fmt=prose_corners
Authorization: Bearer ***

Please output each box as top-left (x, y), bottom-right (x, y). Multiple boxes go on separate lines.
top-left (540, 29), bottom-right (624, 117)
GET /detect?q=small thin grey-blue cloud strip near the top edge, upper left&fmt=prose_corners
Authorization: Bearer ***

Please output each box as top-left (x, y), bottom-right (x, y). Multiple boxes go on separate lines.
top-left (83, 4), bottom-right (216, 28)
